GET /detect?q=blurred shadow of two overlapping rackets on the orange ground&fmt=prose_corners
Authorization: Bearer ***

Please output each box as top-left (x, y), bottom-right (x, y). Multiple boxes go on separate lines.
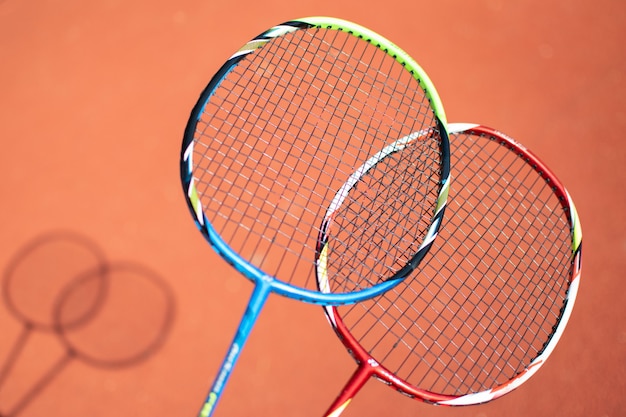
top-left (0, 231), bottom-right (176, 417)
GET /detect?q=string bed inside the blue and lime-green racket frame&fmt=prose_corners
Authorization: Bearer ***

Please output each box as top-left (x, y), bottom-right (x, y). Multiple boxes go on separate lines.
top-left (194, 29), bottom-right (442, 291)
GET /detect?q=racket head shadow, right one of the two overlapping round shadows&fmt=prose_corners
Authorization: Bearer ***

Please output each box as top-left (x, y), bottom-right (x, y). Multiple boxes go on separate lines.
top-left (53, 262), bottom-right (175, 368)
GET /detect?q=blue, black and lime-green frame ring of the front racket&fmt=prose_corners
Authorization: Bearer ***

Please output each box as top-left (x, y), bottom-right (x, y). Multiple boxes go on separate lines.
top-left (180, 16), bottom-right (450, 305)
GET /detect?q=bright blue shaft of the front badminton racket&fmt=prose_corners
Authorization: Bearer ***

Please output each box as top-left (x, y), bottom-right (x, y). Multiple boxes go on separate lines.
top-left (198, 280), bottom-right (272, 417)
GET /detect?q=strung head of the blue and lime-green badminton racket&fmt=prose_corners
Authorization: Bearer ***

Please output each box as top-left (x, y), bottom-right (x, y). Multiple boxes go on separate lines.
top-left (180, 17), bottom-right (450, 305)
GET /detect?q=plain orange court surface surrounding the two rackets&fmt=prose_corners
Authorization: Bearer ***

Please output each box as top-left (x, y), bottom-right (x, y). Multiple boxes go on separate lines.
top-left (0, 0), bottom-right (626, 417)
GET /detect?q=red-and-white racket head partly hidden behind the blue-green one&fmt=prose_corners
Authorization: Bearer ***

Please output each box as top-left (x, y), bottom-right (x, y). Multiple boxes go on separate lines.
top-left (324, 124), bottom-right (582, 406)
